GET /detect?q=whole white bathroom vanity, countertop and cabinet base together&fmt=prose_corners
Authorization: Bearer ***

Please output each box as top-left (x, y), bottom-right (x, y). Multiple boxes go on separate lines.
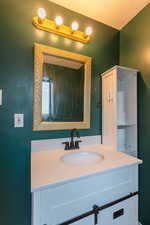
top-left (32, 145), bottom-right (141, 225)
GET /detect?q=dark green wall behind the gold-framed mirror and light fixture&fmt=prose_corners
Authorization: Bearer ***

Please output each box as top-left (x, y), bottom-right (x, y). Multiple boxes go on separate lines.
top-left (0, 0), bottom-right (119, 225)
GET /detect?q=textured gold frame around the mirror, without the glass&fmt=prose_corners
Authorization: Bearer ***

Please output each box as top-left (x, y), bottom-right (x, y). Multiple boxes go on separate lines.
top-left (33, 43), bottom-right (91, 131)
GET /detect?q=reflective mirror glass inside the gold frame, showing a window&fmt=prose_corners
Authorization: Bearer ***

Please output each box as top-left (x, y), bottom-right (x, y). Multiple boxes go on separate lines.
top-left (41, 54), bottom-right (84, 122)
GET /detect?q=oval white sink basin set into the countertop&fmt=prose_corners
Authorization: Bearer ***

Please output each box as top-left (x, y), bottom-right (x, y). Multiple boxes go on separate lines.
top-left (60, 150), bottom-right (104, 165)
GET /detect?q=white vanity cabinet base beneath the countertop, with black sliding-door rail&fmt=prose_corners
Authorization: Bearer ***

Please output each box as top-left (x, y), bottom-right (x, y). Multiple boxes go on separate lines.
top-left (32, 164), bottom-right (138, 225)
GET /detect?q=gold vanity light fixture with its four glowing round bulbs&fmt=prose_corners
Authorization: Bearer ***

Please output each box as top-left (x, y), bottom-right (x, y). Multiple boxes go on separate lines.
top-left (32, 8), bottom-right (93, 43)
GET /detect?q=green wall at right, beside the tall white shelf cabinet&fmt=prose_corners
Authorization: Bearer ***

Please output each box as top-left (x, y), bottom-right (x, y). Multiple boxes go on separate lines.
top-left (120, 4), bottom-right (150, 225)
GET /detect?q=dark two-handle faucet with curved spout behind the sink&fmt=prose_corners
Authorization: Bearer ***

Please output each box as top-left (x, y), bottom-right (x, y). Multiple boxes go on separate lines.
top-left (62, 128), bottom-right (81, 150)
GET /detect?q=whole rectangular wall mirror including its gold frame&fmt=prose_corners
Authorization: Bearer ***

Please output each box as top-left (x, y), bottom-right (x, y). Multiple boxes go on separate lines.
top-left (33, 44), bottom-right (91, 130)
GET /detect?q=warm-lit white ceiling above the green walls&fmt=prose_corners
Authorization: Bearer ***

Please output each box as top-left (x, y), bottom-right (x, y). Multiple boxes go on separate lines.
top-left (50, 0), bottom-right (150, 30)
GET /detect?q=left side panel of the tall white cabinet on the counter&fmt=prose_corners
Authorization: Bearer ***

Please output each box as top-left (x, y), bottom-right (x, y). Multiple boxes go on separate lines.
top-left (102, 70), bottom-right (117, 148)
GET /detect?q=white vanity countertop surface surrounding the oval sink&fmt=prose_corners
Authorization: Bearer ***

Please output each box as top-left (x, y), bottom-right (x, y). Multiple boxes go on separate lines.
top-left (31, 145), bottom-right (142, 192)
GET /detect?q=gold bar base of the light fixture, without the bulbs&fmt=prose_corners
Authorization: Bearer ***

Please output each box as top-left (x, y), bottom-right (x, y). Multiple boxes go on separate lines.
top-left (32, 16), bottom-right (91, 43)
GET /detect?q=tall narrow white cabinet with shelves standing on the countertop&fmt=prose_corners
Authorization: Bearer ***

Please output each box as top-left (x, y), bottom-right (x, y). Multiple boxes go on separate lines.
top-left (102, 66), bottom-right (137, 156)
